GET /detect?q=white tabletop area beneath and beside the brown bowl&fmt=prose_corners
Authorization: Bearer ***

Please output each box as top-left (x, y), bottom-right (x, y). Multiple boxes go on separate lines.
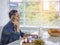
top-left (42, 30), bottom-right (60, 45)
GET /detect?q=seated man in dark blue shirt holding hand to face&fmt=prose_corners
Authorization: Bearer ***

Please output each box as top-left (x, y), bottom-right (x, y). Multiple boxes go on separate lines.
top-left (1, 10), bottom-right (29, 45)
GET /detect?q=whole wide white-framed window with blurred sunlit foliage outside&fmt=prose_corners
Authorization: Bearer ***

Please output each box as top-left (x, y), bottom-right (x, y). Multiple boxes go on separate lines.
top-left (10, 0), bottom-right (60, 26)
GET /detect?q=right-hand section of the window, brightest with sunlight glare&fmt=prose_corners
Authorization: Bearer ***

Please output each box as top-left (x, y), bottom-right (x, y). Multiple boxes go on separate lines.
top-left (42, 0), bottom-right (60, 26)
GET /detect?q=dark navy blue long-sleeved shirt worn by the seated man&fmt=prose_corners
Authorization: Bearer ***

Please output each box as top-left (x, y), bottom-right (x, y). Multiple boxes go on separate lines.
top-left (1, 21), bottom-right (24, 45)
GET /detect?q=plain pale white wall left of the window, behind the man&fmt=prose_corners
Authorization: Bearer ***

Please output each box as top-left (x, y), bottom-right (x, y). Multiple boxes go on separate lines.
top-left (0, 0), bottom-right (9, 26)
